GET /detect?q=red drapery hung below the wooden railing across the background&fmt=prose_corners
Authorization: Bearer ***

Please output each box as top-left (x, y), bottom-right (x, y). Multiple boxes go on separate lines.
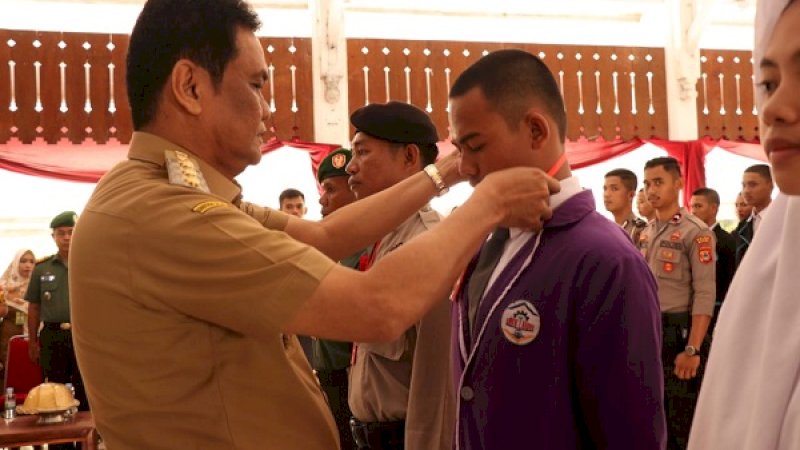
top-left (0, 138), bottom-right (767, 202)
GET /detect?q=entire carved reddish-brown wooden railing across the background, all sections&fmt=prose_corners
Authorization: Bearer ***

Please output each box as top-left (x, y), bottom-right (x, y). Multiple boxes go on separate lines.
top-left (0, 30), bottom-right (758, 144)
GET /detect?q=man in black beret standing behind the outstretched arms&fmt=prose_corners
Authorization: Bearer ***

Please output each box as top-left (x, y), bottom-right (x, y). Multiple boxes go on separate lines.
top-left (347, 102), bottom-right (455, 450)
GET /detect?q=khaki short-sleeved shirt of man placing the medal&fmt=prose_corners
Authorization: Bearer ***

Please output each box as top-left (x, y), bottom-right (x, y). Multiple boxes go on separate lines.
top-left (70, 133), bottom-right (339, 450)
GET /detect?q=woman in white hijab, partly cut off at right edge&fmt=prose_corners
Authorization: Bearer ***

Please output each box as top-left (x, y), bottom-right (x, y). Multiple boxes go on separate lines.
top-left (689, 0), bottom-right (800, 450)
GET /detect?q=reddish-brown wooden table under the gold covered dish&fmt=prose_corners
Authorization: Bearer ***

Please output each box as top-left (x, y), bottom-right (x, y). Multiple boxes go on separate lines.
top-left (0, 411), bottom-right (97, 450)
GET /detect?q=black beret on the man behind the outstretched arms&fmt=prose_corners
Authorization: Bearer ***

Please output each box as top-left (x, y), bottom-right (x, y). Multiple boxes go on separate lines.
top-left (350, 101), bottom-right (439, 144)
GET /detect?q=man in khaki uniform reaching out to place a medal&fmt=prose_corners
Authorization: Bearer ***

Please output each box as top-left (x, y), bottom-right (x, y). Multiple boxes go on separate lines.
top-left (69, 0), bottom-right (559, 450)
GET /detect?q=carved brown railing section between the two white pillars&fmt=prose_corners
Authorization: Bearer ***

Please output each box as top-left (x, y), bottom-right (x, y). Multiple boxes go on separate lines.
top-left (348, 39), bottom-right (667, 140)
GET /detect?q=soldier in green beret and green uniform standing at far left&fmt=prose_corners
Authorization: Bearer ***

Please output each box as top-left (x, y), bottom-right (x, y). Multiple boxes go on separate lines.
top-left (25, 211), bottom-right (89, 411)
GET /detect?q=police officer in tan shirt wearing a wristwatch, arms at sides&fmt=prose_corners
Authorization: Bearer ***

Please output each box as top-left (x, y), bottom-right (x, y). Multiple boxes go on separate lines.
top-left (639, 157), bottom-right (716, 450)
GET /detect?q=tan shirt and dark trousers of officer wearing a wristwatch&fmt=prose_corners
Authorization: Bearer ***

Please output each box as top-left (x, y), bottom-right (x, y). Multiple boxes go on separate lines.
top-left (639, 208), bottom-right (716, 450)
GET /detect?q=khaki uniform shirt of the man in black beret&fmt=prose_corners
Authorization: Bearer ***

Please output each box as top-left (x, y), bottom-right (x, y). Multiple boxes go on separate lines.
top-left (349, 206), bottom-right (455, 450)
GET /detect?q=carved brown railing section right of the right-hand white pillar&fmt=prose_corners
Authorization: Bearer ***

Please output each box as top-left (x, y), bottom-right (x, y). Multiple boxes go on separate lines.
top-left (697, 50), bottom-right (758, 141)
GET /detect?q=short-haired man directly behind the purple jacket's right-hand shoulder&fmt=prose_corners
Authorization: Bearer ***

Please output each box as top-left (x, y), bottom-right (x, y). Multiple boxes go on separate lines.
top-left (603, 169), bottom-right (647, 243)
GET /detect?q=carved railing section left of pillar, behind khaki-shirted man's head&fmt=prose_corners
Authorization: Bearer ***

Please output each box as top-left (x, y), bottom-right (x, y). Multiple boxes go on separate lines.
top-left (0, 30), bottom-right (314, 144)
